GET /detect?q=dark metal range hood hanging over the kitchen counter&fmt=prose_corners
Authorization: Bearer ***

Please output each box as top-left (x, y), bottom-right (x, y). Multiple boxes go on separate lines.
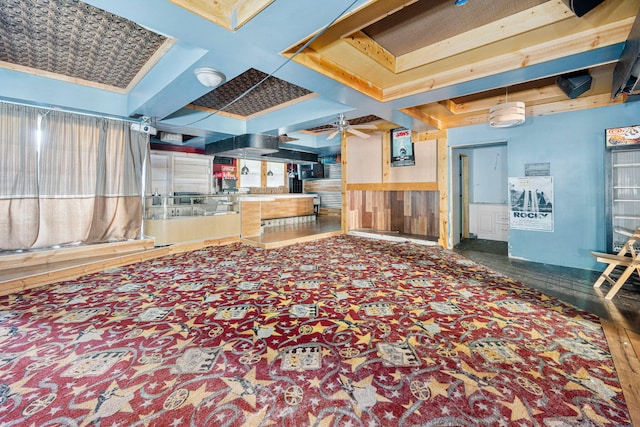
top-left (204, 133), bottom-right (318, 164)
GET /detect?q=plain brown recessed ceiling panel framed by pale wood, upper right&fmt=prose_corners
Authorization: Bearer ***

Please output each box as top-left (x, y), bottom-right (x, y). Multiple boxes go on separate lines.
top-left (362, 0), bottom-right (547, 56)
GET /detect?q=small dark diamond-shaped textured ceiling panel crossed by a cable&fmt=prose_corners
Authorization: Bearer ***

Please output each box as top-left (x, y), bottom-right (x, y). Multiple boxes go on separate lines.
top-left (192, 68), bottom-right (312, 117)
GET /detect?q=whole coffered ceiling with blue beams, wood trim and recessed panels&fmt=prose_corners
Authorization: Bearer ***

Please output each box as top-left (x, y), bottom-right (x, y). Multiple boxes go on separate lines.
top-left (0, 0), bottom-right (640, 150)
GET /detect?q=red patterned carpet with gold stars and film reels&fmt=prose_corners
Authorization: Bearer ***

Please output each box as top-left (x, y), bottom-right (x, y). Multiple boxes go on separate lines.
top-left (0, 236), bottom-right (630, 427)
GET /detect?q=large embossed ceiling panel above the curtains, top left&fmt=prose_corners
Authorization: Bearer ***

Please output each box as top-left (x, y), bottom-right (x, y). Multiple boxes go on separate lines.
top-left (0, 0), bottom-right (166, 89)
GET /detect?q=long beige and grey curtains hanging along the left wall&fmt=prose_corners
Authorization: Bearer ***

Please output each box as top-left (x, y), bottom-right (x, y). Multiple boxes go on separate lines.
top-left (0, 104), bottom-right (149, 250)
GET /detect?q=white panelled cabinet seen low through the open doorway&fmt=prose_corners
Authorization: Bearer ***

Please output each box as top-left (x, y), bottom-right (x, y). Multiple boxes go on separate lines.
top-left (469, 203), bottom-right (509, 242)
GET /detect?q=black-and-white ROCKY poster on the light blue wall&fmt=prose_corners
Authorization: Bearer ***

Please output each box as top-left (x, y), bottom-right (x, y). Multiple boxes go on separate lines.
top-left (509, 176), bottom-right (553, 231)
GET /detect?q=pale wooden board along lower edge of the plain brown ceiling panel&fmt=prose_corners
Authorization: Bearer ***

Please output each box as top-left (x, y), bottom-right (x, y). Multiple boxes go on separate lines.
top-left (395, 0), bottom-right (573, 73)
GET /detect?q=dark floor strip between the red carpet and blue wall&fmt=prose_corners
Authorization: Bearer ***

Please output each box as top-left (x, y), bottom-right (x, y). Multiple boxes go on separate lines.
top-left (454, 239), bottom-right (640, 333)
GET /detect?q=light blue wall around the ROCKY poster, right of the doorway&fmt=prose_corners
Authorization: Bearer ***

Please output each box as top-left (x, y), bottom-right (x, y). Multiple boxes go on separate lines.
top-left (448, 102), bottom-right (640, 270)
